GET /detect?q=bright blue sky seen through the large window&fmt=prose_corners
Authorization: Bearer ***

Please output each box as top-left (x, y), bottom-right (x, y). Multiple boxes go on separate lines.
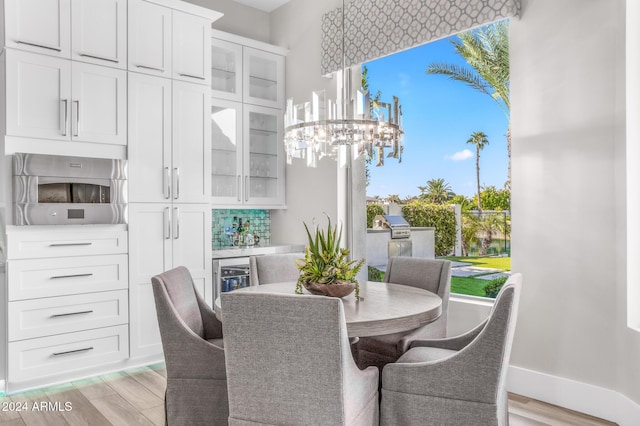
top-left (365, 36), bottom-right (508, 198)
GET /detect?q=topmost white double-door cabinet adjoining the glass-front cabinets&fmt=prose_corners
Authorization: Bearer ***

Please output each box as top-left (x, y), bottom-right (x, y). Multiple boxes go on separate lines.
top-left (129, 0), bottom-right (211, 85)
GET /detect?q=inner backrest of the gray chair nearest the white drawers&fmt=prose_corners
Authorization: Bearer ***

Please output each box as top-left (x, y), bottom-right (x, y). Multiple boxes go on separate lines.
top-left (151, 266), bottom-right (204, 337)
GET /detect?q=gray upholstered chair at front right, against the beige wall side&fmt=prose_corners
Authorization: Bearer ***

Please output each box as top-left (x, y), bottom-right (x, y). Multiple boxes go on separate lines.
top-left (380, 274), bottom-right (522, 426)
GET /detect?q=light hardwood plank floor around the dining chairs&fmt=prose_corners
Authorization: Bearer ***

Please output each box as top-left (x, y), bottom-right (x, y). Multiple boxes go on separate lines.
top-left (0, 365), bottom-right (614, 426)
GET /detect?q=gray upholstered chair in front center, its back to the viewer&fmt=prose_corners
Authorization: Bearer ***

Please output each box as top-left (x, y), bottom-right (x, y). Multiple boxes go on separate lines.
top-left (221, 292), bottom-right (379, 426)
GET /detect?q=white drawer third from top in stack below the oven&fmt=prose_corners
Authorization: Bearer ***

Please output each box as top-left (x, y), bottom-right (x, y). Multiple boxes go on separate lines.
top-left (8, 290), bottom-right (129, 342)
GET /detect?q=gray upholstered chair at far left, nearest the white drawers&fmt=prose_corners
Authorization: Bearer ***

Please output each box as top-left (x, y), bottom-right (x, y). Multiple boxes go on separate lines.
top-left (151, 266), bottom-right (229, 425)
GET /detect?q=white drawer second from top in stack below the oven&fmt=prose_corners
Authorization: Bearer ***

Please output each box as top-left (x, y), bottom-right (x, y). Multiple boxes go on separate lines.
top-left (7, 254), bottom-right (128, 301)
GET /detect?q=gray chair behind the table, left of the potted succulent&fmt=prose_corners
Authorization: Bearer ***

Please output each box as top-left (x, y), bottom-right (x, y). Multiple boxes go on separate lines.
top-left (249, 253), bottom-right (304, 285)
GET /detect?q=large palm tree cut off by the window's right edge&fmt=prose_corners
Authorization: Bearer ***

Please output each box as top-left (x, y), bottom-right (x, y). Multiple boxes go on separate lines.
top-left (427, 20), bottom-right (511, 189)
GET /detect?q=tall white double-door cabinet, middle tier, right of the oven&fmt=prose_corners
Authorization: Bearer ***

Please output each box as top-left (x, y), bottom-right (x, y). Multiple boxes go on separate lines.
top-left (129, 74), bottom-right (211, 203)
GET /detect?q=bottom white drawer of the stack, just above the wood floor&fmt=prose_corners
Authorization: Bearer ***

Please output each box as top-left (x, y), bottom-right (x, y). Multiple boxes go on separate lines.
top-left (8, 325), bottom-right (129, 383)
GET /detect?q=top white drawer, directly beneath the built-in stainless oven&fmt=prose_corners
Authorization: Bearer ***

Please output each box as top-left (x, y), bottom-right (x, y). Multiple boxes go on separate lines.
top-left (7, 225), bottom-right (127, 259)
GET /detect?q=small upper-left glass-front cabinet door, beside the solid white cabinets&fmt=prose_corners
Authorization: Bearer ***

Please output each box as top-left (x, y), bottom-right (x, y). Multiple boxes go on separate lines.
top-left (211, 38), bottom-right (242, 102)
